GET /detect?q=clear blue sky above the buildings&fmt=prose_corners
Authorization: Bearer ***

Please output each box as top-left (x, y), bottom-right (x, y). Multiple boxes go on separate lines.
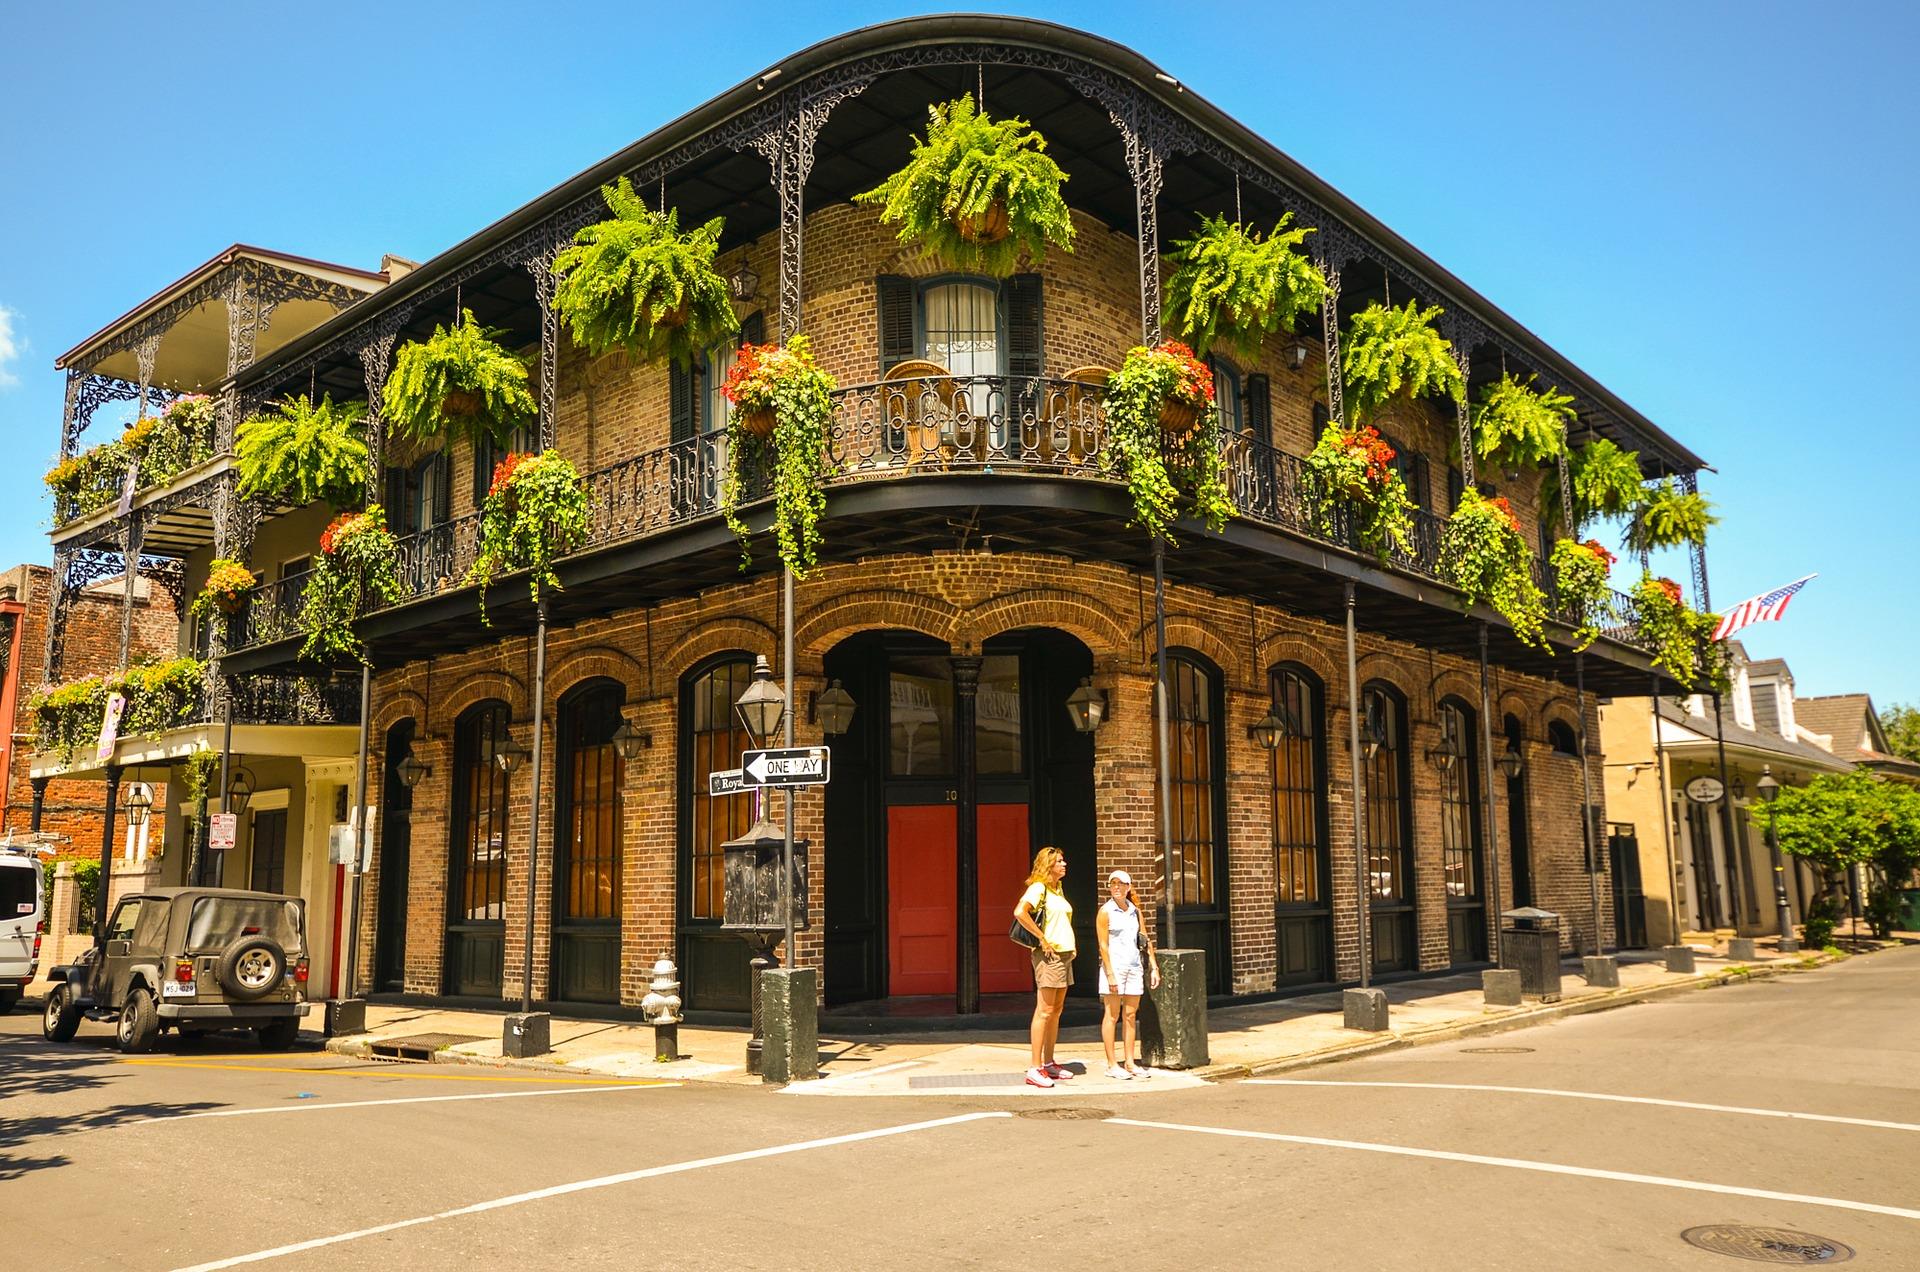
top-left (0, 0), bottom-right (1920, 705)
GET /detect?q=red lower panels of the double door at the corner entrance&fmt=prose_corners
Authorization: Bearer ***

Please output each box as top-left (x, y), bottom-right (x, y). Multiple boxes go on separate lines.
top-left (887, 803), bottom-right (1033, 997)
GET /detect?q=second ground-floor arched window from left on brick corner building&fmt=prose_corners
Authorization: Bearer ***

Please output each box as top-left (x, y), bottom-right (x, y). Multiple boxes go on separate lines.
top-left (445, 701), bottom-right (509, 997)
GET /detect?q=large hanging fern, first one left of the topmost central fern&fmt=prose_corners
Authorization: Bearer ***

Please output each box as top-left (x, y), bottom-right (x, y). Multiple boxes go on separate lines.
top-left (553, 177), bottom-right (739, 367)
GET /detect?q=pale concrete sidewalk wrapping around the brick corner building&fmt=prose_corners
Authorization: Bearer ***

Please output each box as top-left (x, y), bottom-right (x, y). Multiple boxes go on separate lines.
top-left (326, 940), bottom-right (1901, 1097)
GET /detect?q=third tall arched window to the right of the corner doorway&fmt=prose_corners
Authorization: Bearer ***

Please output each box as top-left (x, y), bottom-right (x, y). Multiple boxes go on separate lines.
top-left (1361, 684), bottom-right (1419, 972)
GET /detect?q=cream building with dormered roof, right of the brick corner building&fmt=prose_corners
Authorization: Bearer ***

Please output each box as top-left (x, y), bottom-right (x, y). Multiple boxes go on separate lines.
top-left (1599, 640), bottom-right (1847, 943)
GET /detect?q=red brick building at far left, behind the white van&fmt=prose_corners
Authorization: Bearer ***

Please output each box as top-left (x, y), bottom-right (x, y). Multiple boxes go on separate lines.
top-left (0, 565), bottom-right (180, 859)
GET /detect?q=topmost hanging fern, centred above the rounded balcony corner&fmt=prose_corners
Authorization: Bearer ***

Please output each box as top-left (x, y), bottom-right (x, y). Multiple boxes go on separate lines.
top-left (854, 94), bottom-right (1073, 279)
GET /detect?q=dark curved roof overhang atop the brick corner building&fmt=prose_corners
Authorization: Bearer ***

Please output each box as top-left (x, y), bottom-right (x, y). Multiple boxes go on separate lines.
top-left (240, 15), bottom-right (1705, 473)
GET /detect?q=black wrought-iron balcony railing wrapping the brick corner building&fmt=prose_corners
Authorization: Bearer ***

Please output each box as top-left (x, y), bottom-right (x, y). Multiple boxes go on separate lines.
top-left (236, 377), bottom-right (1644, 648)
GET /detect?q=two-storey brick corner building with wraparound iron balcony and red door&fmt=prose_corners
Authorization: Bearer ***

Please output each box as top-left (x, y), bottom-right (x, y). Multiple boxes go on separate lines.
top-left (33, 17), bottom-right (1703, 1011)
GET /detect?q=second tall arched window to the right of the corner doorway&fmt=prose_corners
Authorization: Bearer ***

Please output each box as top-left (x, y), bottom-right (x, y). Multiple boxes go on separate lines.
top-left (1267, 665), bottom-right (1332, 988)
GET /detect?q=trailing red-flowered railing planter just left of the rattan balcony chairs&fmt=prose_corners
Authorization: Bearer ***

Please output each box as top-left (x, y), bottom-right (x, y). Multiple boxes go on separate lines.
top-left (720, 334), bottom-right (835, 578)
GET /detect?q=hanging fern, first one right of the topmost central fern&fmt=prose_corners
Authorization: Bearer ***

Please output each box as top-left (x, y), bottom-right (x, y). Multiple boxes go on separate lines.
top-left (1167, 213), bottom-right (1327, 355)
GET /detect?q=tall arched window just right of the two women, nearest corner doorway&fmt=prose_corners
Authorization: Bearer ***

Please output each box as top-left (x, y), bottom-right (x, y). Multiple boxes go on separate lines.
top-left (1165, 649), bottom-right (1229, 991)
